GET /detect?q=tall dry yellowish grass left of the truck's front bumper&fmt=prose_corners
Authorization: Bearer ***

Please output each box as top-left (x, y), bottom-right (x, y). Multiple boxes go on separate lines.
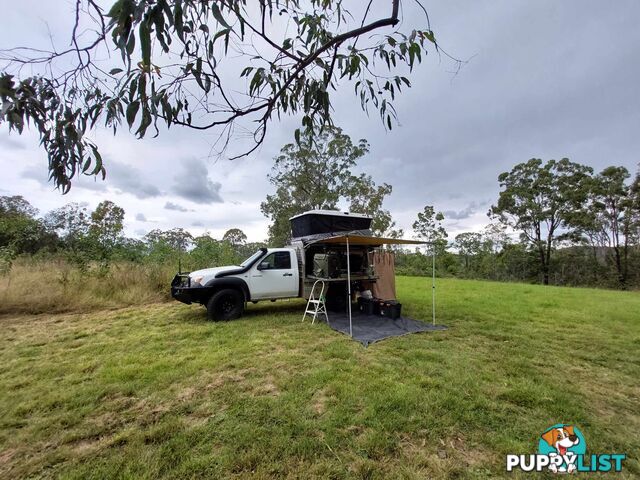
top-left (0, 258), bottom-right (176, 314)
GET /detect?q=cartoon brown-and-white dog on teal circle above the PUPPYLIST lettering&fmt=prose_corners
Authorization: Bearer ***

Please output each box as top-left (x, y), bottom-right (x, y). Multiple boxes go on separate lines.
top-left (538, 423), bottom-right (587, 473)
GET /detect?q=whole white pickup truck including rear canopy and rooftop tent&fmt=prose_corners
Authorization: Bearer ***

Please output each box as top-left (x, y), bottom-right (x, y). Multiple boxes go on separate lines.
top-left (171, 210), bottom-right (390, 320)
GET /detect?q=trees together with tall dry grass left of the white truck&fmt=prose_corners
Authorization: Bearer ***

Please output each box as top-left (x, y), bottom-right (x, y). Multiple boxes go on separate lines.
top-left (0, 196), bottom-right (262, 314)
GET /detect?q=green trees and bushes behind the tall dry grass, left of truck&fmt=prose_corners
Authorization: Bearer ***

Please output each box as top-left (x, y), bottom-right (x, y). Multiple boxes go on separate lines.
top-left (0, 196), bottom-right (263, 278)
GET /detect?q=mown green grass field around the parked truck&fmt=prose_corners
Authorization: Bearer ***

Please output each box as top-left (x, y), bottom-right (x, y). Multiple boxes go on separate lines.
top-left (0, 278), bottom-right (640, 479)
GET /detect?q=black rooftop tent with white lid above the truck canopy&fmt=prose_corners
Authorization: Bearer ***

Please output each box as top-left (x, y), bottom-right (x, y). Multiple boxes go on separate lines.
top-left (289, 210), bottom-right (371, 238)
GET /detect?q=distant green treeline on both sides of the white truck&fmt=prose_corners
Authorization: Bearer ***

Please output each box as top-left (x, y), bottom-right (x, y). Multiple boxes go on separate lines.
top-left (0, 159), bottom-right (640, 293)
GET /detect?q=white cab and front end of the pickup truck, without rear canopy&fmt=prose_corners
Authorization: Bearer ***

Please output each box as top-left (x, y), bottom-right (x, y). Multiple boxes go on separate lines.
top-left (171, 247), bottom-right (303, 321)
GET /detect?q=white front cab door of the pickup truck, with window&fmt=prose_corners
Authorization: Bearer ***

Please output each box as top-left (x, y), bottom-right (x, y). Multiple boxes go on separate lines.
top-left (249, 250), bottom-right (298, 300)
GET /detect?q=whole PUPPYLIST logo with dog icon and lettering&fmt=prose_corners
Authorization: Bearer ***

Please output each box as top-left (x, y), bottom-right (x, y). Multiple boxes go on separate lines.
top-left (507, 423), bottom-right (626, 473)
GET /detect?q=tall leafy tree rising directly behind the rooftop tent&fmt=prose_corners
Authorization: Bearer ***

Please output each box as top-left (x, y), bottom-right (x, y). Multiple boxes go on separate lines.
top-left (260, 127), bottom-right (393, 245)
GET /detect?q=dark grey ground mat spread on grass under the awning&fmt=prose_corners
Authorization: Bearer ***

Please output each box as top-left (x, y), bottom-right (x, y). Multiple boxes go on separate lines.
top-left (329, 312), bottom-right (447, 347)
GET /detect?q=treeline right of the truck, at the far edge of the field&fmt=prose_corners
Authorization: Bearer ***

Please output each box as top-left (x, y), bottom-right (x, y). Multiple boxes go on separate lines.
top-left (397, 158), bottom-right (640, 288)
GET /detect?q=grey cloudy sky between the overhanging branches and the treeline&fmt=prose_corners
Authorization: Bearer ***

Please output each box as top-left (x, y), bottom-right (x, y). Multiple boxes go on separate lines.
top-left (0, 0), bottom-right (640, 241)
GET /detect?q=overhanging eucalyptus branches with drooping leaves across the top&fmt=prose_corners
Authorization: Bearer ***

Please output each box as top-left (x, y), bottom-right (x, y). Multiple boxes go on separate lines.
top-left (0, 0), bottom-right (458, 192)
